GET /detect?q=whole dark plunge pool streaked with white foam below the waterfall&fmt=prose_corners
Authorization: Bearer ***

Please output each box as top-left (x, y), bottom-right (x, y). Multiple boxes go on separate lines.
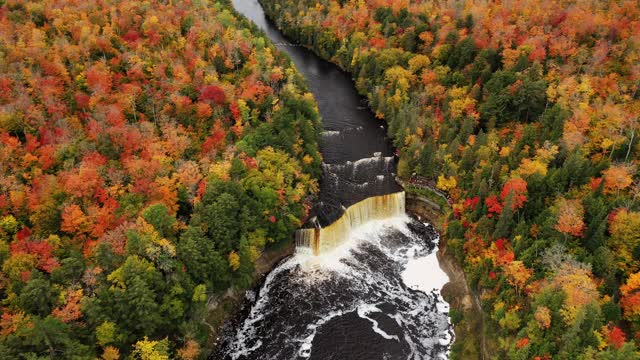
top-left (218, 215), bottom-right (453, 360)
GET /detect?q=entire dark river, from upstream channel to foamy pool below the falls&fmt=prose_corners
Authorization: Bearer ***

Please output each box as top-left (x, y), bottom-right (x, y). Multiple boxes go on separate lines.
top-left (212, 0), bottom-right (453, 360)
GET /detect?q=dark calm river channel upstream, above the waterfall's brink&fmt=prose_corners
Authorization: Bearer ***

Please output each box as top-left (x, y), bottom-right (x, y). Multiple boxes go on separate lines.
top-left (232, 0), bottom-right (401, 226)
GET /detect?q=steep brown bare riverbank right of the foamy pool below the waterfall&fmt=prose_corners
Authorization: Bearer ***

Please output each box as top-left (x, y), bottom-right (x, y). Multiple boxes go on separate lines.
top-left (406, 193), bottom-right (490, 359)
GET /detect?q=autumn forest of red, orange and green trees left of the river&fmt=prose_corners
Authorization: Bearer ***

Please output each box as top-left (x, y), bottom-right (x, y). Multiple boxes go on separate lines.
top-left (0, 0), bottom-right (321, 360)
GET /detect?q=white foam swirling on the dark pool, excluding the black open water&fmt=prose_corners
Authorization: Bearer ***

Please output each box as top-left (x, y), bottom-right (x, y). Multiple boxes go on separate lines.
top-left (222, 215), bottom-right (454, 360)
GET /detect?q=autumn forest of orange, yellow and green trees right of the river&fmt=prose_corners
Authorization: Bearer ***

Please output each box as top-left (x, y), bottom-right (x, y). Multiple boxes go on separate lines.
top-left (261, 0), bottom-right (640, 360)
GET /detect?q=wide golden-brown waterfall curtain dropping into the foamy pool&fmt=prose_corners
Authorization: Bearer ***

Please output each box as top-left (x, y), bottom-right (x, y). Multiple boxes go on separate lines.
top-left (296, 191), bottom-right (405, 255)
